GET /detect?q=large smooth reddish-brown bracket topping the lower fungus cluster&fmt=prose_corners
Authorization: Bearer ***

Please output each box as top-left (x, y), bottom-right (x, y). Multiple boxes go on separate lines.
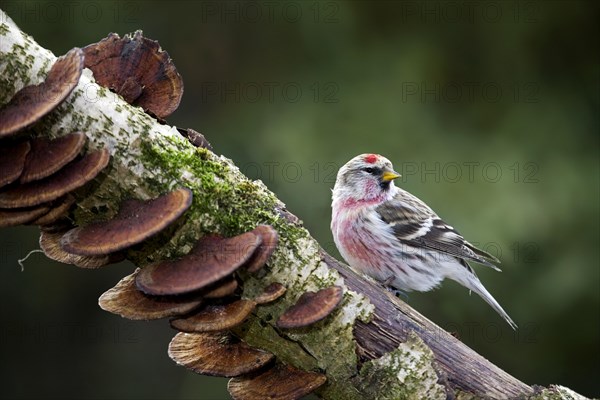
top-left (137, 232), bottom-right (260, 295)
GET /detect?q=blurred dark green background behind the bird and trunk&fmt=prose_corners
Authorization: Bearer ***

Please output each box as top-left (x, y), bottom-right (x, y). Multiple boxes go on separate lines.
top-left (0, 1), bottom-right (600, 399)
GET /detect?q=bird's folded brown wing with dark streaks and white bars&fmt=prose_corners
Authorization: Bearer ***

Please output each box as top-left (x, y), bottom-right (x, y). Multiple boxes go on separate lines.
top-left (375, 192), bottom-right (500, 271)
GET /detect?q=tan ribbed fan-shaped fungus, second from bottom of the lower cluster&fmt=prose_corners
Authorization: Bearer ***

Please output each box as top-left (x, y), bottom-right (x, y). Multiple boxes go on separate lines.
top-left (169, 332), bottom-right (275, 378)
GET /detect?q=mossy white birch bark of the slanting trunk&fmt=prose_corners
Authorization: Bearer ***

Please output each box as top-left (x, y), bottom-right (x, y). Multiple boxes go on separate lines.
top-left (0, 10), bottom-right (588, 399)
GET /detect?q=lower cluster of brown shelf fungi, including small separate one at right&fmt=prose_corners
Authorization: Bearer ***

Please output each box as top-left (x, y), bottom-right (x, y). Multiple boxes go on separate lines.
top-left (100, 225), bottom-right (342, 400)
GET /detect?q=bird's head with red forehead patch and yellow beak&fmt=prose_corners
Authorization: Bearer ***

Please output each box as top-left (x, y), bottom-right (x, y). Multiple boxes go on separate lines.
top-left (333, 154), bottom-right (400, 203)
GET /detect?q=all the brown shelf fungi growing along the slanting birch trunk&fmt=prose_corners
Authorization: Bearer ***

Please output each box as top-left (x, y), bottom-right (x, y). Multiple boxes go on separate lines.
top-left (0, 32), bottom-right (343, 400)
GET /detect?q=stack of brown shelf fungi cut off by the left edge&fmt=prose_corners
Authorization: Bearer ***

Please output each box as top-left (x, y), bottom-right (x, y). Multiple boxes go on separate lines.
top-left (0, 48), bottom-right (110, 231)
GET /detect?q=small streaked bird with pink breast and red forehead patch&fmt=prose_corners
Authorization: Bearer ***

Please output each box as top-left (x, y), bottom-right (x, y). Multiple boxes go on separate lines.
top-left (331, 154), bottom-right (517, 330)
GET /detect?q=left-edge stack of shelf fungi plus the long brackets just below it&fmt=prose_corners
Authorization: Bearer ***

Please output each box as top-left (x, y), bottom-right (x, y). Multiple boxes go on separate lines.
top-left (0, 48), bottom-right (192, 268)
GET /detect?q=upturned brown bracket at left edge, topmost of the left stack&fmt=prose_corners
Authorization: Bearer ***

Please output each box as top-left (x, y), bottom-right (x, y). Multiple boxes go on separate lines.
top-left (0, 48), bottom-right (83, 139)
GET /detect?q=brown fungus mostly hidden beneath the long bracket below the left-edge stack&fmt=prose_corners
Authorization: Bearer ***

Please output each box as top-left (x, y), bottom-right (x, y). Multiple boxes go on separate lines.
top-left (40, 231), bottom-right (125, 269)
